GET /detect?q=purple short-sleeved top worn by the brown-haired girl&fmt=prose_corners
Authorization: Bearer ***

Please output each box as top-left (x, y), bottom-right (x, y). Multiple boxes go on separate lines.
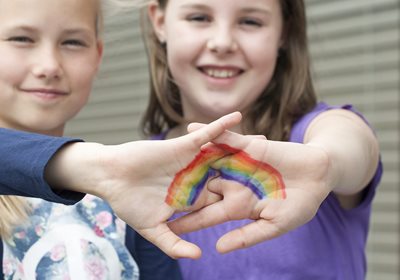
top-left (179, 103), bottom-right (382, 280)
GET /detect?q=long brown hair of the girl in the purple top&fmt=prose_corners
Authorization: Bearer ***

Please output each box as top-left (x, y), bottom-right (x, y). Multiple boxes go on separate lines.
top-left (141, 0), bottom-right (317, 140)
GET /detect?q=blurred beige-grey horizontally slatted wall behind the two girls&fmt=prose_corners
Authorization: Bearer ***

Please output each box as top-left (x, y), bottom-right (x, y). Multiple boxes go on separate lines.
top-left (66, 0), bottom-right (400, 280)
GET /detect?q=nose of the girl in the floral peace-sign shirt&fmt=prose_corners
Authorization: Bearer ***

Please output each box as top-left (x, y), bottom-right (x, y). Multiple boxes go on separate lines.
top-left (32, 46), bottom-right (63, 81)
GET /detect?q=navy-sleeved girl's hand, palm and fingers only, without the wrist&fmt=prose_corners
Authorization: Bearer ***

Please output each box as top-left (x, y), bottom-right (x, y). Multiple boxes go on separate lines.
top-left (90, 113), bottom-right (241, 258)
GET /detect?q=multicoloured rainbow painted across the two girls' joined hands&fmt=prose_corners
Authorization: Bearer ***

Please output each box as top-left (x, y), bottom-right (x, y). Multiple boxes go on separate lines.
top-left (165, 144), bottom-right (286, 209)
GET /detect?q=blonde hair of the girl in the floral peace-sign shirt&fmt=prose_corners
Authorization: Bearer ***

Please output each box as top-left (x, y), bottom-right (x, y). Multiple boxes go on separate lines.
top-left (0, 0), bottom-right (105, 239)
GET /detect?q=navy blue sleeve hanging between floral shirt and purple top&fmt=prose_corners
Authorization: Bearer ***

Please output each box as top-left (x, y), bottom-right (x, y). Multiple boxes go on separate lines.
top-left (126, 225), bottom-right (182, 280)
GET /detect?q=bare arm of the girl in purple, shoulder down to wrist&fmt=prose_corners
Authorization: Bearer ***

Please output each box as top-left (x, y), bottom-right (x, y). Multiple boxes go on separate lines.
top-left (305, 110), bottom-right (379, 195)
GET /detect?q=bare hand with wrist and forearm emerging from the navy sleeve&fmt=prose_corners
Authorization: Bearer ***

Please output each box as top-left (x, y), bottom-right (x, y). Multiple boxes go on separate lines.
top-left (45, 112), bottom-right (241, 258)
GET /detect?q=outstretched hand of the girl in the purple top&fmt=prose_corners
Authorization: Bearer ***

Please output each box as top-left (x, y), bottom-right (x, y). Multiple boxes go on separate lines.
top-left (169, 132), bottom-right (330, 253)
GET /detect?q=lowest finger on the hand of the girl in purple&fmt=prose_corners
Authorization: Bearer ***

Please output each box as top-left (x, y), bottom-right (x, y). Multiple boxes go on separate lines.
top-left (216, 220), bottom-right (284, 253)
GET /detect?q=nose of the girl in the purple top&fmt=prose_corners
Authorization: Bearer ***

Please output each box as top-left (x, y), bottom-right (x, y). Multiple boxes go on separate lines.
top-left (207, 25), bottom-right (238, 54)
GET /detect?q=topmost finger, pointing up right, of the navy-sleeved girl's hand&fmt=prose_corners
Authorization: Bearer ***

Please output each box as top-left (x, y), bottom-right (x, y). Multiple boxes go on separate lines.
top-left (188, 112), bottom-right (242, 147)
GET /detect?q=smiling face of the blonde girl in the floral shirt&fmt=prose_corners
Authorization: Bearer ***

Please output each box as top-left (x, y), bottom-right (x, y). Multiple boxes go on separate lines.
top-left (0, 0), bottom-right (102, 135)
